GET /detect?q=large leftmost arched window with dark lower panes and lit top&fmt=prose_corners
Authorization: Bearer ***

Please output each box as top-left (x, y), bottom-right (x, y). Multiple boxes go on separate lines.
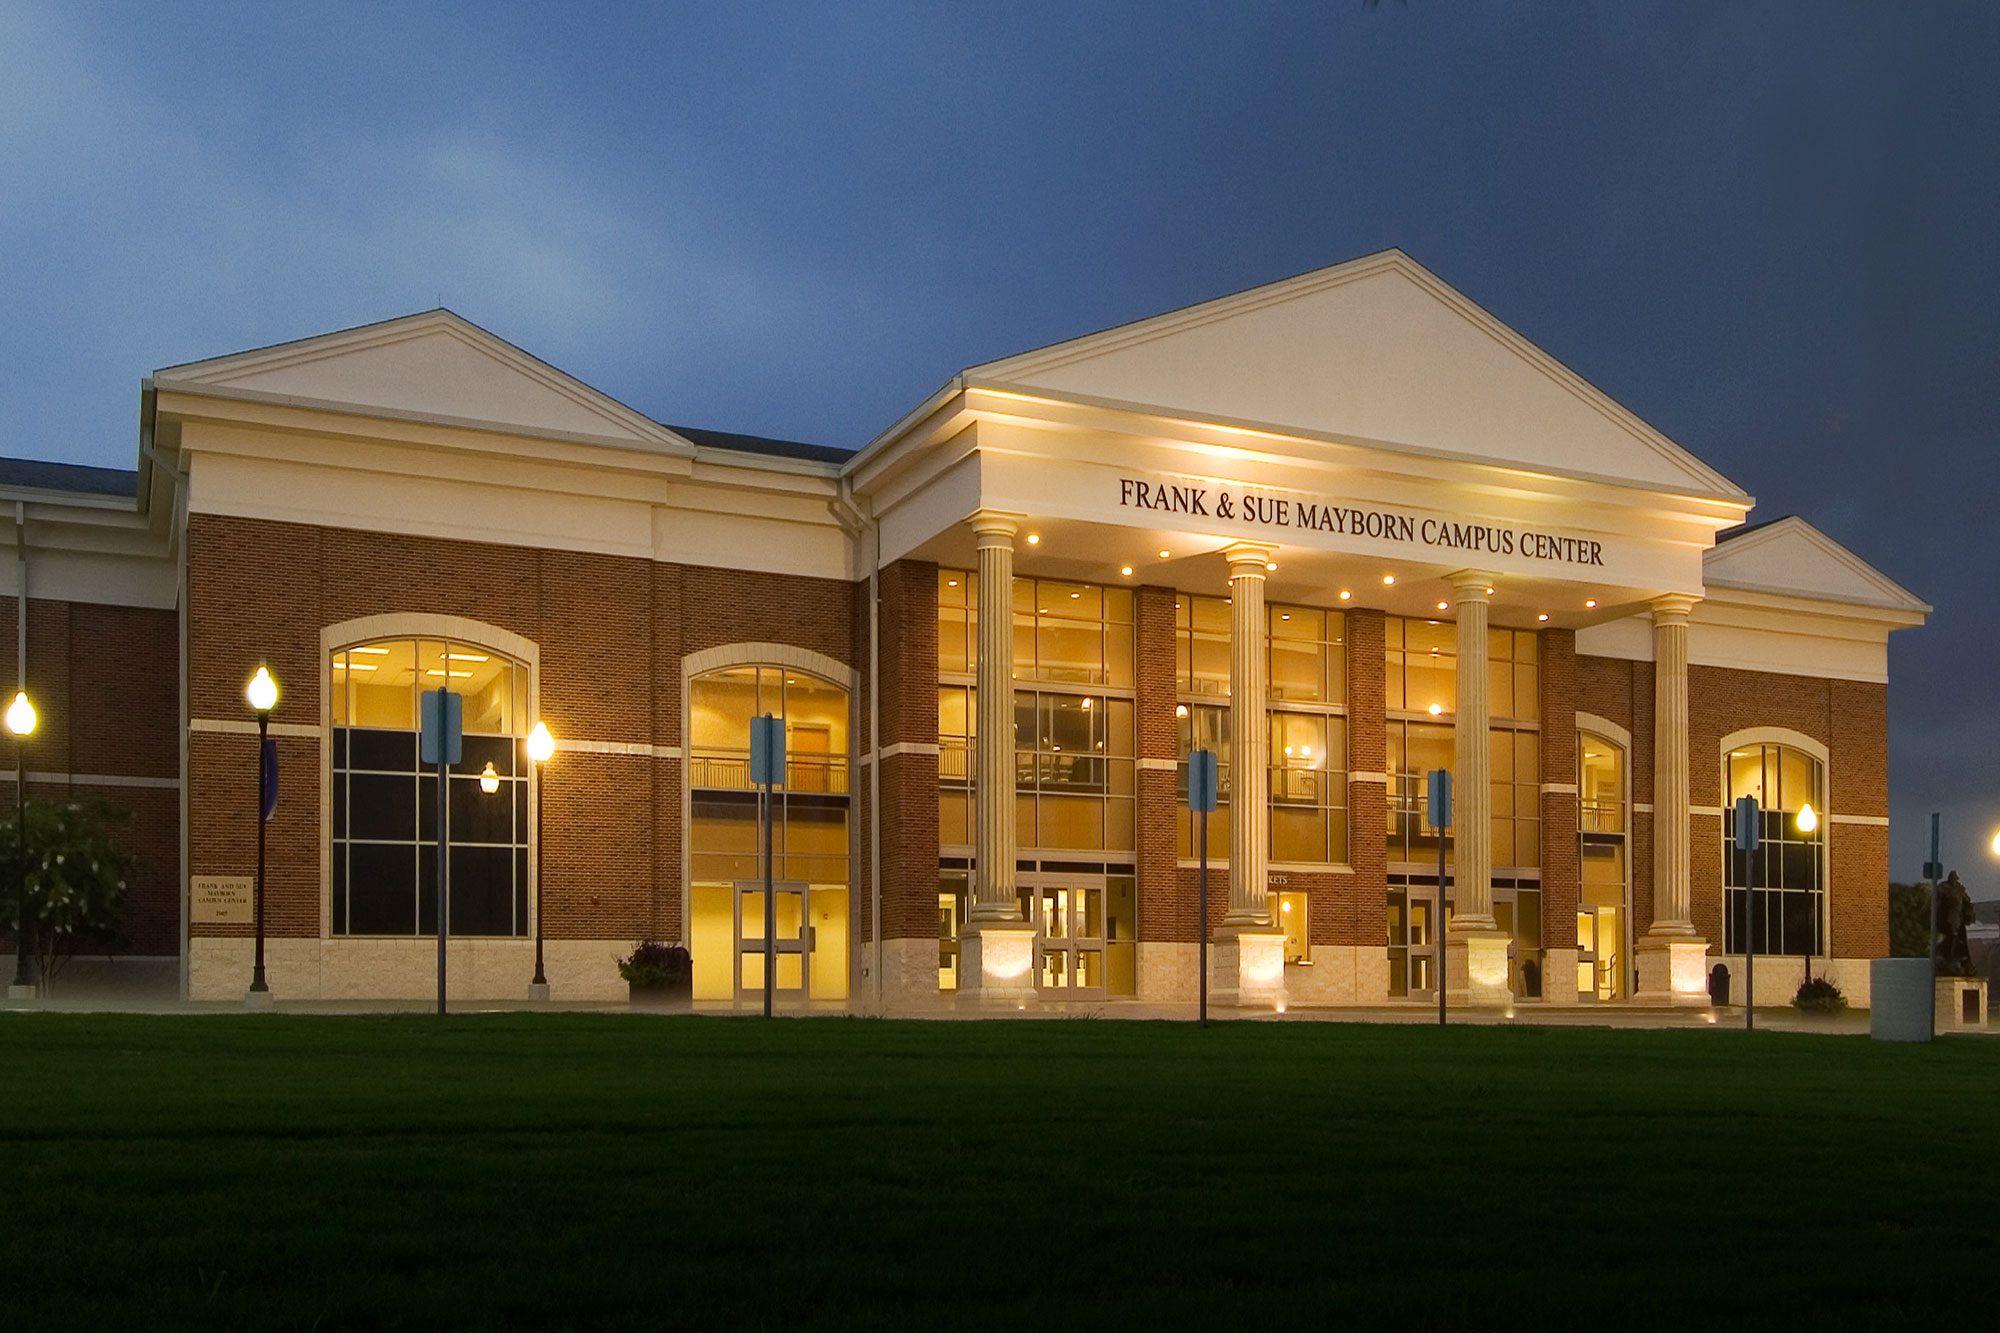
top-left (328, 636), bottom-right (528, 937)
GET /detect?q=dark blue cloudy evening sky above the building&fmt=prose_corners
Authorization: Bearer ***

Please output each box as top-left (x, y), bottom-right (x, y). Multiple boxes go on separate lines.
top-left (0, 0), bottom-right (2000, 880)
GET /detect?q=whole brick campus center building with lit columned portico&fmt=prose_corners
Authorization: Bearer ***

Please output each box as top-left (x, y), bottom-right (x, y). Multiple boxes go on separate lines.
top-left (4, 250), bottom-right (1928, 1007)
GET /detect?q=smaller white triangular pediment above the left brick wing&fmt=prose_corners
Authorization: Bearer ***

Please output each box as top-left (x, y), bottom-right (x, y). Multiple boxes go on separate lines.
top-left (154, 310), bottom-right (694, 454)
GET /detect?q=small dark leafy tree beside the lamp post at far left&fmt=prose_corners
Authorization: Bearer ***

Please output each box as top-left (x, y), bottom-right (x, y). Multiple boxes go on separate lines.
top-left (0, 801), bottom-right (132, 987)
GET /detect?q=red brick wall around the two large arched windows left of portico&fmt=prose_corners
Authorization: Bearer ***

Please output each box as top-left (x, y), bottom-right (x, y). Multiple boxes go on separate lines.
top-left (188, 514), bottom-right (866, 939)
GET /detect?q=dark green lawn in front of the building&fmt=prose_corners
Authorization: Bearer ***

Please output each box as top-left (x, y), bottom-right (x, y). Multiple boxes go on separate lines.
top-left (0, 1015), bottom-right (2000, 1329)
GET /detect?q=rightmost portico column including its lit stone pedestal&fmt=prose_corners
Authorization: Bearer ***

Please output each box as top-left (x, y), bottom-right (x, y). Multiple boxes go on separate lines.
top-left (1634, 594), bottom-right (1708, 1005)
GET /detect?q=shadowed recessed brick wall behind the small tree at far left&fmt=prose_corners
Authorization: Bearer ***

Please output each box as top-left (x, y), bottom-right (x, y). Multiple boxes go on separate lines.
top-left (0, 592), bottom-right (180, 957)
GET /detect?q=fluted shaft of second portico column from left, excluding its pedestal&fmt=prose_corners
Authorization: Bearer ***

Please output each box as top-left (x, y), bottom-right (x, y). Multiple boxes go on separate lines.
top-left (1222, 542), bottom-right (1272, 931)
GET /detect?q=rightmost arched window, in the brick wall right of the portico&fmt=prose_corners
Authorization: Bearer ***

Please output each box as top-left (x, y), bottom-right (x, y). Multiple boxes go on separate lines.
top-left (1722, 741), bottom-right (1826, 957)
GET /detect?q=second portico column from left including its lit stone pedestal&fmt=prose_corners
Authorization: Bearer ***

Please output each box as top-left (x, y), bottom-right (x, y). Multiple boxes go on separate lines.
top-left (1202, 542), bottom-right (1284, 1007)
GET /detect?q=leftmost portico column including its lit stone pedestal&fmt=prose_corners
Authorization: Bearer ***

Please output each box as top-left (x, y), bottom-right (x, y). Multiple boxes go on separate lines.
top-left (958, 510), bottom-right (1034, 1007)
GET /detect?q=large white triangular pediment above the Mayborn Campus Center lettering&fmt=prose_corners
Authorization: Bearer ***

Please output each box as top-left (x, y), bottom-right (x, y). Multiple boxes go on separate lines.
top-left (966, 250), bottom-right (1748, 500)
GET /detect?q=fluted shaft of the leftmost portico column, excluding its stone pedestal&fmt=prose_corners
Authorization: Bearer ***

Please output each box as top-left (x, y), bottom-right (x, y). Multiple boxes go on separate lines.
top-left (966, 510), bottom-right (1020, 923)
